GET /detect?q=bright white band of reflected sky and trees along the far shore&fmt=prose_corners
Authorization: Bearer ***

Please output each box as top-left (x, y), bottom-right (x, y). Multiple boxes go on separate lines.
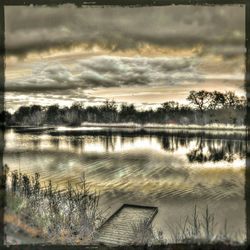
top-left (7, 130), bottom-right (246, 163)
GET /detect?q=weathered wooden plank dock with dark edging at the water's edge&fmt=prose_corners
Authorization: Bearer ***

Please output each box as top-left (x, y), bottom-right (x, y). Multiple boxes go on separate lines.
top-left (96, 204), bottom-right (158, 245)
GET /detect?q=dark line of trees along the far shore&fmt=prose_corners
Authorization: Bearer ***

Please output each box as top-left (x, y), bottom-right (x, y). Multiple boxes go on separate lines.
top-left (1, 90), bottom-right (246, 126)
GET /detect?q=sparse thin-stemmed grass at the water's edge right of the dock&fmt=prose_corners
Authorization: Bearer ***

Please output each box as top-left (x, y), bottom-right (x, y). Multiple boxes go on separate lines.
top-left (132, 205), bottom-right (245, 245)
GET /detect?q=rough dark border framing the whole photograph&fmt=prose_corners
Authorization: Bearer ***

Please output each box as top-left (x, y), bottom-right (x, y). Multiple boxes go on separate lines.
top-left (0, 0), bottom-right (250, 249)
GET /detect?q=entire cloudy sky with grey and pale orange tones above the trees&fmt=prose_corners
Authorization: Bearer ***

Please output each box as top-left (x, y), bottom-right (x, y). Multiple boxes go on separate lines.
top-left (5, 5), bottom-right (245, 111)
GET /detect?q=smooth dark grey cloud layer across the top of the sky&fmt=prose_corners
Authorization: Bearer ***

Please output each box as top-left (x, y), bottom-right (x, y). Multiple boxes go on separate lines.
top-left (5, 5), bottom-right (245, 55)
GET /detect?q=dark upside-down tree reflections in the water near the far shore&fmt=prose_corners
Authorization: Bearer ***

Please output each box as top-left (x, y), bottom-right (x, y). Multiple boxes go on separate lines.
top-left (45, 130), bottom-right (246, 163)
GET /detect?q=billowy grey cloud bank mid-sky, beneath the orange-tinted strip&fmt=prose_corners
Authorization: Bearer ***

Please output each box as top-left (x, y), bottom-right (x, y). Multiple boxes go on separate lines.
top-left (6, 56), bottom-right (198, 94)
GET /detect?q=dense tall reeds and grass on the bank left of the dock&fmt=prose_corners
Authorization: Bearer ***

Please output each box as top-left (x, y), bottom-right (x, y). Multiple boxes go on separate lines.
top-left (6, 165), bottom-right (104, 244)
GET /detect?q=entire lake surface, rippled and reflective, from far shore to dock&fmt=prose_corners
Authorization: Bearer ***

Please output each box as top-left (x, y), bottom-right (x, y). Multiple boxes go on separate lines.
top-left (4, 128), bottom-right (246, 239)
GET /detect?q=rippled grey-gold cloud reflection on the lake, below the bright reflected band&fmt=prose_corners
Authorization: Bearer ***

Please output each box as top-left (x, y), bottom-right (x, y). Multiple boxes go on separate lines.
top-left (5, 148), bottom-right (244, 199)
